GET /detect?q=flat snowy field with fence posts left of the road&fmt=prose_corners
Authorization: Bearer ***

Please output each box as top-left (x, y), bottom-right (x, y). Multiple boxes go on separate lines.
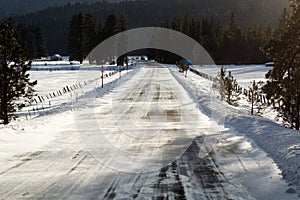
top-left (18, 61), bottom-right (136, 119)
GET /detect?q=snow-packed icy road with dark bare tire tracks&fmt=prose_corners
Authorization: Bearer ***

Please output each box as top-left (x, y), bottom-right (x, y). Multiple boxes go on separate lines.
top-left (0, 65), bottom-right (295, 199)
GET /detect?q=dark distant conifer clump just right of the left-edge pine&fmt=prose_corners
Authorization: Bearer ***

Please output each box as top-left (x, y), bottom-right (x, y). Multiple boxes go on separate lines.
top-left (17, 23), bottom-right (47, 59)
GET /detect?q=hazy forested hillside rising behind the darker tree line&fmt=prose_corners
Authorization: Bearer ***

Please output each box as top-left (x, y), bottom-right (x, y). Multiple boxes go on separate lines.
top-left (14, 0), bottom-right (287, 56)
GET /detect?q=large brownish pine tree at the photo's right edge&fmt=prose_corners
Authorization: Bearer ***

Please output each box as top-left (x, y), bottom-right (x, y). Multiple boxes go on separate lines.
top-left (263, 0), bottom-right (300, 130)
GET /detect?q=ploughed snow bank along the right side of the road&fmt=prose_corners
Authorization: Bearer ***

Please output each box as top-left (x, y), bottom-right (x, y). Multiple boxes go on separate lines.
top-left (170, 66), bottom-right (300, 195)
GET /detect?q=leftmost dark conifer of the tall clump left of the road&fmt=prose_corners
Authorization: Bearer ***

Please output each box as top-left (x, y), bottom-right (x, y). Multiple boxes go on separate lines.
top-left (68, 13), bottom-right (84, 63)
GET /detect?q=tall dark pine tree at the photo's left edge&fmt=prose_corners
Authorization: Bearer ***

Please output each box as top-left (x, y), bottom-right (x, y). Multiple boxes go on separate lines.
top-left (0, 21), bottom-right (37, 124)
